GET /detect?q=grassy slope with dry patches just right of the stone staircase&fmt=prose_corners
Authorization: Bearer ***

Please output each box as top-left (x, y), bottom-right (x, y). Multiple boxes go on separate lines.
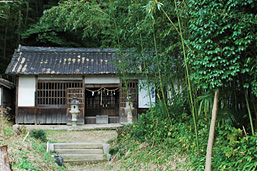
top-left (110, 125), bottom-right (185, 170)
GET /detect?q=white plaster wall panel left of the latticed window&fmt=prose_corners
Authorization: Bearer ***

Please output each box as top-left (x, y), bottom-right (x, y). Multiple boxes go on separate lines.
top-left (18, 76), bottom-right (36, 107)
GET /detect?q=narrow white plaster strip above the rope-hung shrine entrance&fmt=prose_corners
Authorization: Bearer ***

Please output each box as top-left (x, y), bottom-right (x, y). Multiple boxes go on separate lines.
top-left (85, 77), bottom-right (120, 84)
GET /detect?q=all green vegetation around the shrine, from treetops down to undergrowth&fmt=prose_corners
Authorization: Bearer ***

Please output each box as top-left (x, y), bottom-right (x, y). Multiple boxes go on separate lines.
top-left (0, 0), bottom-right (257, 170)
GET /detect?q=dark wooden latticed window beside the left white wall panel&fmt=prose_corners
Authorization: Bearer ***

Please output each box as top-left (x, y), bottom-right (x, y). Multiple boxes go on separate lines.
top-left (36, 80), bottom-right (83, 106)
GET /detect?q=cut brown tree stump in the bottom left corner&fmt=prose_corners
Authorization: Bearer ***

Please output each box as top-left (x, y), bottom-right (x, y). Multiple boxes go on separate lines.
top-left (0, 145), bottom-right (12, 171)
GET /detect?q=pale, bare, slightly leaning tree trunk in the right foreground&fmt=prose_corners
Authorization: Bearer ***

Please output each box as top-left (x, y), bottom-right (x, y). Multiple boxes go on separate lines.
top-left (205, 90), bottom-right (219, 171)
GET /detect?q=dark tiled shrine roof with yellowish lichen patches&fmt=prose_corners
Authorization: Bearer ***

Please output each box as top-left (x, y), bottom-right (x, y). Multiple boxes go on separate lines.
top-left (6, 46), bottom-right (117, 75)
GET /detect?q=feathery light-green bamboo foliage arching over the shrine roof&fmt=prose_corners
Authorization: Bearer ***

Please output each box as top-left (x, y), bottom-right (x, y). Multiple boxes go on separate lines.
top-left (41, 0), bottom-right (184, 108)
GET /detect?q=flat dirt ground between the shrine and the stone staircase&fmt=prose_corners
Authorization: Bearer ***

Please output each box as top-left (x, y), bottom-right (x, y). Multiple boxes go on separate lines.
top-left (45, 130), bottom-right (117, 143)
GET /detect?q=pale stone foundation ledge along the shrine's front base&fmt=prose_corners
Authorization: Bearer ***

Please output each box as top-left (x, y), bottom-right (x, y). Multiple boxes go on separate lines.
top-left (14, 123), bottom-right (123, 131)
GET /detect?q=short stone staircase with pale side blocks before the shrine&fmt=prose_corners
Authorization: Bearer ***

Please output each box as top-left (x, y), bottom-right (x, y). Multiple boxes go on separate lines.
top-left (47, 143), bottom-right (109, 163)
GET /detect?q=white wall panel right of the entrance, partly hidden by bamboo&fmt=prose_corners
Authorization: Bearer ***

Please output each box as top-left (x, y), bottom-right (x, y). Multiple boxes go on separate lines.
top-left (138, 80), bottom-right (155, 108)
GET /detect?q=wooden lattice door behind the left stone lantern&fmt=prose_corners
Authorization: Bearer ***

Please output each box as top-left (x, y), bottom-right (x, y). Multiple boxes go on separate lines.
top-left (66, 88), bottom-right (85, 125)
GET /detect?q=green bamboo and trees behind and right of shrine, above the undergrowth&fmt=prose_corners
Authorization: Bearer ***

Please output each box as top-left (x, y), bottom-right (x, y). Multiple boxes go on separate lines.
top-left (0, 0), bottom-right (257, 170)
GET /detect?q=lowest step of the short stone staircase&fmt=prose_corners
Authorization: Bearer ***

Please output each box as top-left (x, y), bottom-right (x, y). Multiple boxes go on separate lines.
top-left (60, 154), bottom-right (104, 162)
